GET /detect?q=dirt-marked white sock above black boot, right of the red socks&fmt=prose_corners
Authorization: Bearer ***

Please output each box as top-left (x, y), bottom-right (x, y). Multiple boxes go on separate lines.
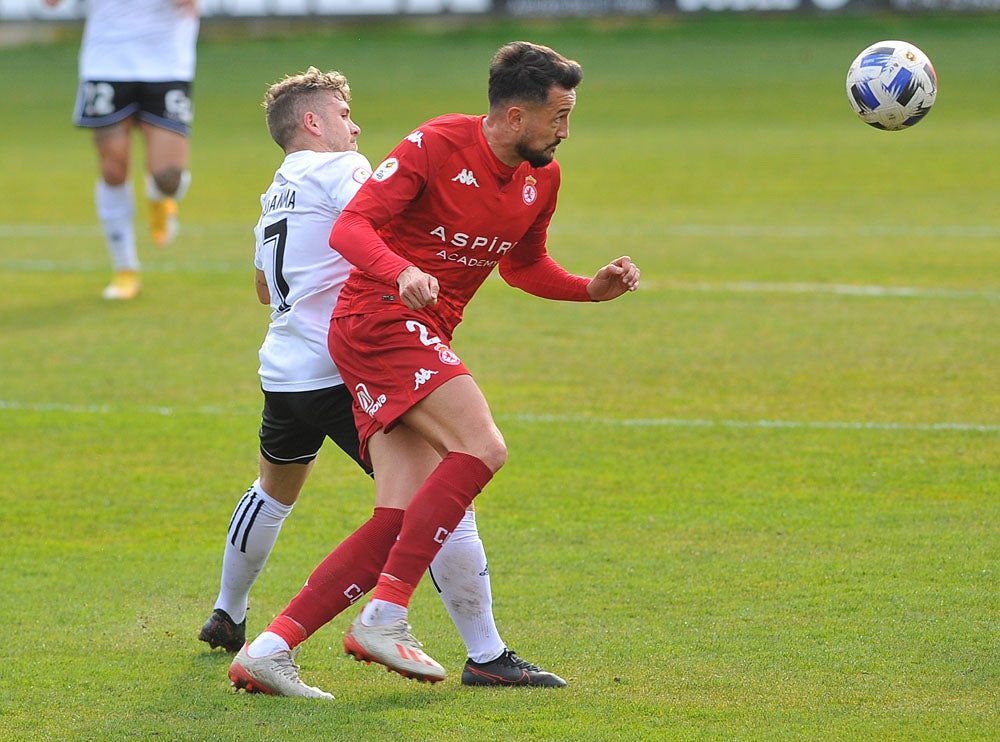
top-left (430, 510), bottom-right (506, 662)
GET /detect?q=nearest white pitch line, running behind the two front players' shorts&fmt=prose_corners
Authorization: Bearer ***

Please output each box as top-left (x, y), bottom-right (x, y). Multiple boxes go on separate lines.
top-left (0, 400), bottom-right (1000, 433)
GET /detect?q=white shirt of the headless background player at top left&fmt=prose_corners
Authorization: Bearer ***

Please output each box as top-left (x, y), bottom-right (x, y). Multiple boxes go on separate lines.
top-left (80, 0), bottom-right (199, 82)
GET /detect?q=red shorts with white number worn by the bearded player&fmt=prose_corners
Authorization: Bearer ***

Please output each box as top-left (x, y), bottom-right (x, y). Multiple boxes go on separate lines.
top-left (328, 310), bottom-right (469, 462)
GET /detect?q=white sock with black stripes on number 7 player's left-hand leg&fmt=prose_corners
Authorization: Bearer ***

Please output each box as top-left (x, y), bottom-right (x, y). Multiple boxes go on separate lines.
top-left (215, 479), bottom-right (292, 628)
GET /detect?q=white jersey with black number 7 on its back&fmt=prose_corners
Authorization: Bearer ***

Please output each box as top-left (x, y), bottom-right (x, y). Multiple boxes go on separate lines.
top-left (254, 151), bottom-right (371, 392)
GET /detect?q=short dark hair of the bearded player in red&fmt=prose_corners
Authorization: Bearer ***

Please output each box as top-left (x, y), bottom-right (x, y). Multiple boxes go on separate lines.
top-left (488, 41), bottom-right (583, 108)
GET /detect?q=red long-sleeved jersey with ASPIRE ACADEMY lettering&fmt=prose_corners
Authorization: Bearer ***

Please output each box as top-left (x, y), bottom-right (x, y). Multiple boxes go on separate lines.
top-left (330, 114), bottom-right (590, 339)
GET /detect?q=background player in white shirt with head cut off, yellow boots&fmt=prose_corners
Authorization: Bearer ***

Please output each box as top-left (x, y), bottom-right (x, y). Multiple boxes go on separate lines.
top-left (45, 0), bottom-right (199, 299)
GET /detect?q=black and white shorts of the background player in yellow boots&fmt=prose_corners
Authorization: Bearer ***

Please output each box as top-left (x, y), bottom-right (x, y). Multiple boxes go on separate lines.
top-left (73, 80), bottom-right (194, 136)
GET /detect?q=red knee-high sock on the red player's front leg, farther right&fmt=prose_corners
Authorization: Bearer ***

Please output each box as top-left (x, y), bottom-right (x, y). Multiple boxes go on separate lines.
top-left (372, 451), bottom-right (493, 606)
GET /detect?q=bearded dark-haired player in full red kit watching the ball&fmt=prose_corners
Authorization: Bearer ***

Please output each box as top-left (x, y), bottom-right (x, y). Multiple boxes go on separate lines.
top-left (242, 42), bottom-right (639, 685)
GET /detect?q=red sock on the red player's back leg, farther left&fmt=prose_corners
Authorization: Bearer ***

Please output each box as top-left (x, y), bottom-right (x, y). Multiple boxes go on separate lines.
top-left (267, 508), bottom-right (403, 649)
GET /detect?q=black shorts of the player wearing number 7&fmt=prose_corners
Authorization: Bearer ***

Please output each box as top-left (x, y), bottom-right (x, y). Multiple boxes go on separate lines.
top-left (260, 384), bottom-right (371, 475)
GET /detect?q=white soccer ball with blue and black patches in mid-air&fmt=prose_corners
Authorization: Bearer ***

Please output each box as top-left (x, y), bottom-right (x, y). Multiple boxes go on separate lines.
top-left (847, 41), bottom-right (937, 131)
